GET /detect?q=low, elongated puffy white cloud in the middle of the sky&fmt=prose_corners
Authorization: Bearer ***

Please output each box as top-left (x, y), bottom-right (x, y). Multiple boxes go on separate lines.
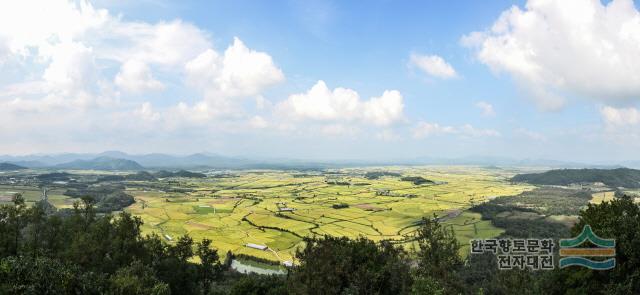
top-left (276, 81), bottom-right (404, 126)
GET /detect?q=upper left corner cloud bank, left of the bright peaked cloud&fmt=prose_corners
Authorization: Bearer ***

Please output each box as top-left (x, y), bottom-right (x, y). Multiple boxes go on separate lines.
top-left (0, 0), bottom-right (212, 107)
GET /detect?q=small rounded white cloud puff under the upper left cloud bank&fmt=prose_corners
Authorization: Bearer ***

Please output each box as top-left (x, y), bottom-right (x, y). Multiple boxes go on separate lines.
top-left (114, 60), bottom-right (164, 93)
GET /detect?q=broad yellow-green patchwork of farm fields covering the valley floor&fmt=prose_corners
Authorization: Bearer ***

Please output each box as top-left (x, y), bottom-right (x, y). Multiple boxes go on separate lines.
top-left (126, 167), bottom-right (533, 262)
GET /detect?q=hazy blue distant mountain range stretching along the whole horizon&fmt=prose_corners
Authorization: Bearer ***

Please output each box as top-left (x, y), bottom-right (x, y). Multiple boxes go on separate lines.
top-left (0, 151), bottom-right (640, 170)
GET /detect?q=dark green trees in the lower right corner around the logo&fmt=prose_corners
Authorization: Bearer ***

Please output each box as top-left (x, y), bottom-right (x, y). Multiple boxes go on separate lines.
top-left (463, 196), bottom-right (640, 294)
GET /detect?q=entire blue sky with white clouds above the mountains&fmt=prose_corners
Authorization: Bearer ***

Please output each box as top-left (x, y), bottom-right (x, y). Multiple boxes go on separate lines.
top-left (0, 0), bottom-right (640, 162)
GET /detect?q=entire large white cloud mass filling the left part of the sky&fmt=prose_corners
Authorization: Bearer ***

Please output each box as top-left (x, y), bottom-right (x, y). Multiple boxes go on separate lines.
top-left (0, 0), bottom-right (284, 148)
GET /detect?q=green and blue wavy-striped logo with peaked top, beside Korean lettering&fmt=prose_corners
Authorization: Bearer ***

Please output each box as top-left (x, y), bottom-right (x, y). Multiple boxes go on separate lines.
top-left (559, 225), bottom-right (616, 270)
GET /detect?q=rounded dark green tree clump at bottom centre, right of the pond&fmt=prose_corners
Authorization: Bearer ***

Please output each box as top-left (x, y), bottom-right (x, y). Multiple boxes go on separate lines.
top-left (288, 236), bottom-right (412, 294)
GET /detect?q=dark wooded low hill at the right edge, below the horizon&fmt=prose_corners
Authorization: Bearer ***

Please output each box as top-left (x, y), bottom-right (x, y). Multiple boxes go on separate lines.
top-left (511, 168), bottom-right (640, 188)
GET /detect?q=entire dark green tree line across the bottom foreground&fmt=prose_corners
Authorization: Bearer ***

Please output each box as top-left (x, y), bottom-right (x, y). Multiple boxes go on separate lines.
top-left (0, 195), bottom-right (640, 294)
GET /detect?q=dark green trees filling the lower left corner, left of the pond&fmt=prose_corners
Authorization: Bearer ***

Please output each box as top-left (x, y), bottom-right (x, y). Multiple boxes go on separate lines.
top-left (0, 196), bottom-right (223, 294)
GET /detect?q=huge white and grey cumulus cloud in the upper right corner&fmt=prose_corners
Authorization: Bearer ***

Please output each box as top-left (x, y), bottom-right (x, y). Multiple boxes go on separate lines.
top-left (462, 0), bottom-right (640, 110)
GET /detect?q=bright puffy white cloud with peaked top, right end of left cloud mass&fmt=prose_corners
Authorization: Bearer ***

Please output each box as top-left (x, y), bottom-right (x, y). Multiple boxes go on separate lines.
top-left (185, 38), bottom-right (284, 97)
